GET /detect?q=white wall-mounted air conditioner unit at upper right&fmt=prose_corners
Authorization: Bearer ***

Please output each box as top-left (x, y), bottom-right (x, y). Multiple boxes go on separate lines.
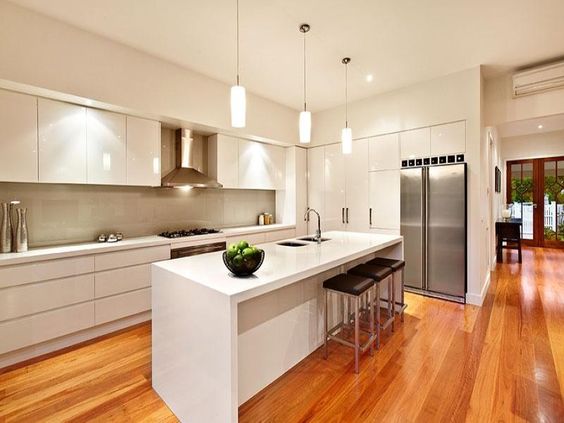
top-left (513, 62), bottom-right (564, 97)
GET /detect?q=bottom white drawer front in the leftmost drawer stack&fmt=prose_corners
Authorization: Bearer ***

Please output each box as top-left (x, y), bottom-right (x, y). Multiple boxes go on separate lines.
top-left (0, 301), bottom-right (94, 354)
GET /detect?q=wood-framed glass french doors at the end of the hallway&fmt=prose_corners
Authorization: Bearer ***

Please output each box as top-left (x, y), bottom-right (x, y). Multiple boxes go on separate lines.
top-left (506, 157), bottom-right (564, 248)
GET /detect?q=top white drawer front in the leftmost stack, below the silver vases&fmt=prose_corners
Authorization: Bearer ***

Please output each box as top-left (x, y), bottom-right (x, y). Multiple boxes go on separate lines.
top-left (0, 256), bottom-right (94, 288)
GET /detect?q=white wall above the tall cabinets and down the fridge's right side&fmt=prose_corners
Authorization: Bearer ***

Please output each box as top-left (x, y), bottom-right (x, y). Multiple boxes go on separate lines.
top-left (312, 67), bottom-right (488, 304)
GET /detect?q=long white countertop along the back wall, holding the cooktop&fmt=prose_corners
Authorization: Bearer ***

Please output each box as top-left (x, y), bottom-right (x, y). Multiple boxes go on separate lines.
top-left (0, 224), bottom-right (295, 266)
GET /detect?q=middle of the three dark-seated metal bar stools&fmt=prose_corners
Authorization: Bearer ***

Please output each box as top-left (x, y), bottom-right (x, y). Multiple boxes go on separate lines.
top-left (349, 264), bottom-right (395, 340)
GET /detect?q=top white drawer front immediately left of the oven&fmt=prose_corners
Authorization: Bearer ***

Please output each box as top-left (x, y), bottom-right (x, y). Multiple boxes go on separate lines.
top-left (94, 245), bottom-right (170, 272)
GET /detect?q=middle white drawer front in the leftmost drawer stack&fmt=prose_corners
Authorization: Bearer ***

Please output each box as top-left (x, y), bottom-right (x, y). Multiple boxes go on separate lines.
top-left (0, 273), bottom-right (94, 321)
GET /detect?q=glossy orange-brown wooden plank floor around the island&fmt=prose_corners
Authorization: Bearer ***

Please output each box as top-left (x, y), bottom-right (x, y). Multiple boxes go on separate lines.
top-left (0, 249), bottom-right (564, 423)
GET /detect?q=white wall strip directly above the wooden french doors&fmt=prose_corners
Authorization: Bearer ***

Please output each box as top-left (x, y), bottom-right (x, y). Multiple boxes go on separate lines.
top-left (502, 130), bottom-right (564, 161)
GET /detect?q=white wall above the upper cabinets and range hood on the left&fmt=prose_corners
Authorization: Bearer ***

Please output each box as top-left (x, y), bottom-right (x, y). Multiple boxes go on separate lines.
top-left (0, 0), bottom-right (298, 144)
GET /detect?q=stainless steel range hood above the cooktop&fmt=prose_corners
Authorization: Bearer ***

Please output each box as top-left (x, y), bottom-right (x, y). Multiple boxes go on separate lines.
top-left (161, 129), bottom-right (223, 188)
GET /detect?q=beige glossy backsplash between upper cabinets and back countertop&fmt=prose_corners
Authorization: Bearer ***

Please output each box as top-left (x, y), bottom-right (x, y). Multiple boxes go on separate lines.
top-left (0, 183), bottom-right (275, 247)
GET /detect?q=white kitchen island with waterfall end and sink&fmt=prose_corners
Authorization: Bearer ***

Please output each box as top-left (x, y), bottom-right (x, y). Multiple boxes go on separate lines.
top-left (152, 232), bottom-right (403, 423)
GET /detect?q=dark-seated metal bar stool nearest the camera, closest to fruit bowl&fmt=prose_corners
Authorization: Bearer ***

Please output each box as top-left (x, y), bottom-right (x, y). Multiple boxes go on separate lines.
top-left (323, 273), bottom-right (375, 373)
